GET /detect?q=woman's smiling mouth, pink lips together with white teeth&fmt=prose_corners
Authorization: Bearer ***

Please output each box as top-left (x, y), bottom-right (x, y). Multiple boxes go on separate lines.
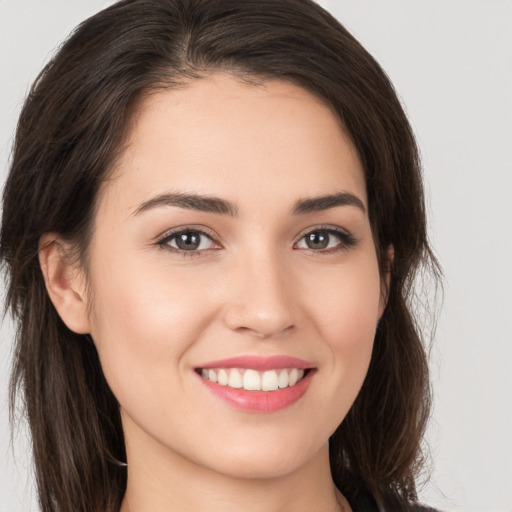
top-left (194, 356), bottom-right (316, 413)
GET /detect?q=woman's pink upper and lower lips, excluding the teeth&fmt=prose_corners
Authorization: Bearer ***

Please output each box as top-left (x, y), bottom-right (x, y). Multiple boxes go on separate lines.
top-left (198, 356), bottom-right (316, 413)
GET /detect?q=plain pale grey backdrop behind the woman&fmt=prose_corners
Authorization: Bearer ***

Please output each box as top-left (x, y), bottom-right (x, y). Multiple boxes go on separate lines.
top-left (0, 0), bottom-right (512, 512)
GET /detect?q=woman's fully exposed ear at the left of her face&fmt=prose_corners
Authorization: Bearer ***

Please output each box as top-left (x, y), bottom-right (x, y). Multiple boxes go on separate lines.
top-left (39, 233), bottom-right (90, 334)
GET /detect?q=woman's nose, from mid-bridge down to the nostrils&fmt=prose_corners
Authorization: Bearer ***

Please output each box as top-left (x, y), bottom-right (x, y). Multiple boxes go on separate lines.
top-left (224, 253), bottom-right (296, 338)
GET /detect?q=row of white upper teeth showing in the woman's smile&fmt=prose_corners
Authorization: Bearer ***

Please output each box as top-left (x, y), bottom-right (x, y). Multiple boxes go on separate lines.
top-left (201, 368), bottom-right (304, 391)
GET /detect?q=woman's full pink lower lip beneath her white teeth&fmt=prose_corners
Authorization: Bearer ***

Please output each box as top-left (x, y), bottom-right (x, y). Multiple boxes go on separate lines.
top-left (199, 370), bottom-right (314, 412)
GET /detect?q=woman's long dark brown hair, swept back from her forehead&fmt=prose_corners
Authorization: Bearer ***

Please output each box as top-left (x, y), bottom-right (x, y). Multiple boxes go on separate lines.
top-left (0, 0), bottom-right (438, 512)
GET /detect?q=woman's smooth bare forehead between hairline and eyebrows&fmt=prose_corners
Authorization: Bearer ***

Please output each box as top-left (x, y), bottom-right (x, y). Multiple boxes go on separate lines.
top-left (103, 74), bottom-right (366, 216)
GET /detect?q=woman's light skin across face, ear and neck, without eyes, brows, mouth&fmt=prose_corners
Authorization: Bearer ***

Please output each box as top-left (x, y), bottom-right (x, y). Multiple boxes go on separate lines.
top-left (40, 74), bottom-right (385, 512)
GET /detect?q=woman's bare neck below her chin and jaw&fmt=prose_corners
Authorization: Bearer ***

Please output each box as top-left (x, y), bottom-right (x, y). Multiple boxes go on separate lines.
top-left (121, 422), bottom-right (350, 512)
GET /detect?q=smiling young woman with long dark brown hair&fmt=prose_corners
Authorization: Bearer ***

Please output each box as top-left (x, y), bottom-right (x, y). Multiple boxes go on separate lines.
top-left (1, 0), bottom-right (437, 512)
